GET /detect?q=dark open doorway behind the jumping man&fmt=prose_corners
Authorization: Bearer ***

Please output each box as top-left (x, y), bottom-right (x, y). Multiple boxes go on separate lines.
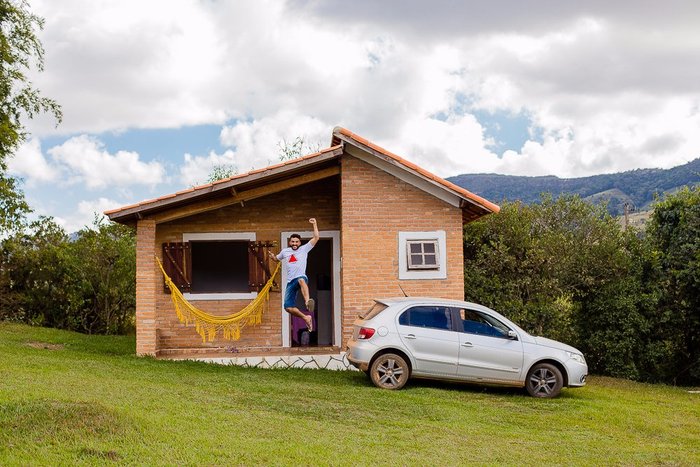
top-left (291, 238), bottom-right (333, 347)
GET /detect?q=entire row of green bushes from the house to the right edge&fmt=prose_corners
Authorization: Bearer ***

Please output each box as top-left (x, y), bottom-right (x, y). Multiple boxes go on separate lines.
top-left (464, 192), bottom-right (700, 384)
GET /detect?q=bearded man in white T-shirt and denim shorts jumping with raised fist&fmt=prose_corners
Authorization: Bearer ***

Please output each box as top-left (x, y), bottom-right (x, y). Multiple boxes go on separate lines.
top-left (269, 217), bottom-right (321, 332)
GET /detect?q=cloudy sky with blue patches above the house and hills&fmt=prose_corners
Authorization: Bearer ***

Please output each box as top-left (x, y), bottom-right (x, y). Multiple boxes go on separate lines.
top-left (5, 0), bottom-right (700, 231)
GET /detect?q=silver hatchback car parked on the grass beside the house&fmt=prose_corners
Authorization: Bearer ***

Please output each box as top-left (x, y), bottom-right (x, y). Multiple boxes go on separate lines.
top-left (347, 297), bottom-right (588, 397)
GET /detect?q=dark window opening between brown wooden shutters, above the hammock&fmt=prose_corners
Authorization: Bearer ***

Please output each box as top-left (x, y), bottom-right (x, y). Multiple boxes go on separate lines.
top-left (191, 241), bottom-right (249, 293)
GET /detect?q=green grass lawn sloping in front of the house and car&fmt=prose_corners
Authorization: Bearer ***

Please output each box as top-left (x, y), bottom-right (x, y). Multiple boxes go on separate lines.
top-left (0, 322), bottom-right (700, 465)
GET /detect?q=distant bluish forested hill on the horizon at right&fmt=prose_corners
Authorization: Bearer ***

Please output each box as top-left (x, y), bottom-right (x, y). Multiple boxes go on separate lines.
top-left (447, 158), bottom-right (700, 216)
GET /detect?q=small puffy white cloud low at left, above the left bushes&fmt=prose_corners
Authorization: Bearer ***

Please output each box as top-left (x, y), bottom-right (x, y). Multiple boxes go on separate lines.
top-left (48, 135), bottom-right (165, 189)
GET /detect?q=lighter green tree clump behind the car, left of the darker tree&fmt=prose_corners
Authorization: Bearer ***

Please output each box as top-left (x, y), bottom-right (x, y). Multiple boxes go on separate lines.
top-left (464, 195), bottom-right (656, 378)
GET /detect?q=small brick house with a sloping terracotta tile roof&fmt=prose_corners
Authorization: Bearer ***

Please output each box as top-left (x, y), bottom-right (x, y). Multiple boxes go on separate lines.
top-left (105, 128), bottom-right (499, 365)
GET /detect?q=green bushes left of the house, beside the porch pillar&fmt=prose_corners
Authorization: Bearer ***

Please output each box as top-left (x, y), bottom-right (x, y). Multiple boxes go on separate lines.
top-left (0, 218), bottom-right (136, 334)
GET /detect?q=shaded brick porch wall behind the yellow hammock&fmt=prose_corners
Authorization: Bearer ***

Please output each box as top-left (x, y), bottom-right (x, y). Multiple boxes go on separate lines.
top-left (148, 177), bottom-right (340, 351)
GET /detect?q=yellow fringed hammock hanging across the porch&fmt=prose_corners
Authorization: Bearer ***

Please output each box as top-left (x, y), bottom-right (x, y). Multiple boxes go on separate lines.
top-left (156, 257), bottom-right (282, 342)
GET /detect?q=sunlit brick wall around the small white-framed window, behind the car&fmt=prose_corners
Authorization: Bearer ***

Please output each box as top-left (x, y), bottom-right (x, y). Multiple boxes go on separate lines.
top-left (341, 156), bottom-right (464, 346)
